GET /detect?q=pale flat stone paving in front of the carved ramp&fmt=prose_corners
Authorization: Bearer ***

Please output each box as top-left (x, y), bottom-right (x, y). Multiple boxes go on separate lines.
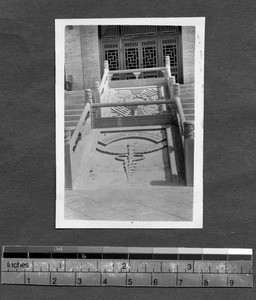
top-left (65, 186), bottom-right (193, 222)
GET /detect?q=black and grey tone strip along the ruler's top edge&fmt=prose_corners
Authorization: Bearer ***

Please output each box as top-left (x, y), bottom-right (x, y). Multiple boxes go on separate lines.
top-left (2, 246), bottom-right (252, 261)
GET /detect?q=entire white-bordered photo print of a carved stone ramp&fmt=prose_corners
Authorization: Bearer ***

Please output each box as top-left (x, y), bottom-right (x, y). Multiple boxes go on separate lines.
top-left (55, 18), bottom-right (205, 228)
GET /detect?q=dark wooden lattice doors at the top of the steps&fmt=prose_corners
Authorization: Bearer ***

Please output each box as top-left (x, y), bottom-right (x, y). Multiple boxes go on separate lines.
top-left (102, 26), bottom-right (183, 83)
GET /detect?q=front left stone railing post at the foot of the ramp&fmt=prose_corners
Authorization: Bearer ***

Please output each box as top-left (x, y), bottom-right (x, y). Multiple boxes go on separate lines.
top-left (64, 130), bottom-right (73, 190)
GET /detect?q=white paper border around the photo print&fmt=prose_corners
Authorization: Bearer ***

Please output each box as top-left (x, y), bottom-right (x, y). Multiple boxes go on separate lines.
top-left (55, 17), bottom-right (205, 229)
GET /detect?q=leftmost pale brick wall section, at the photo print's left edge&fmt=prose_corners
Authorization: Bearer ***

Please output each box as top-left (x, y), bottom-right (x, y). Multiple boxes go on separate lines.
top-left (65, 26), bottom-right (84, 90)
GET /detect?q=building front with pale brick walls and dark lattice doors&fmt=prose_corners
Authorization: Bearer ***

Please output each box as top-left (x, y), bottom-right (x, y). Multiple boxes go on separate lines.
top-left (65, 25), bottom-right (195, 90)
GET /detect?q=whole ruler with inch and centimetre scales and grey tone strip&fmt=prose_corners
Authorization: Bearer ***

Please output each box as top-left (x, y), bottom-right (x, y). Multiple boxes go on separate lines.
top-left (1, 246), bottom-right (253, 287)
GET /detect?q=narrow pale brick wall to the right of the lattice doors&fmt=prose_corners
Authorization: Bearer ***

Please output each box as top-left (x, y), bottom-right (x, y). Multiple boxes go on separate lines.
top-left (182, 26), bottom-right (195, 83)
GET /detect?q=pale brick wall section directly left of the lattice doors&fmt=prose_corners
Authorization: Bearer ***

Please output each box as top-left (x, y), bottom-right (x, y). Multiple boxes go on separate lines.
top-left (80, 26), bottom-right (101, 89)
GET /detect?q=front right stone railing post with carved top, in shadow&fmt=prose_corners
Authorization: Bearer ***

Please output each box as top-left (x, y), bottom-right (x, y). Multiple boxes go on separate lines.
top-left (184, 121), bottom-right (194, 186)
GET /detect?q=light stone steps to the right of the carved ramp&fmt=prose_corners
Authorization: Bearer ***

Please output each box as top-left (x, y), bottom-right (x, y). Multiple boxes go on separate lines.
top-left (180, 84), bottom-right (195, 121)
